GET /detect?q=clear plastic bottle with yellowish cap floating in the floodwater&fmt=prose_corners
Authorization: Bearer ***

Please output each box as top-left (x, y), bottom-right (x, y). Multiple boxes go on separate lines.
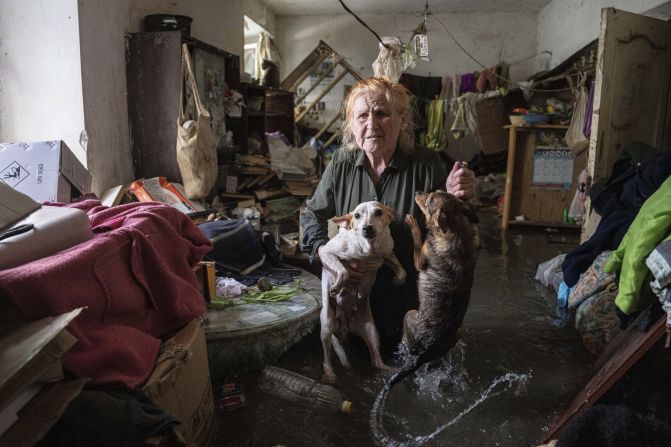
top-left (259, 366), bottom-right (352, 413)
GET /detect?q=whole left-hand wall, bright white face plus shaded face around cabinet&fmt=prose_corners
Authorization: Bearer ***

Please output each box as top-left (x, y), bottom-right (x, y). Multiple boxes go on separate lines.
top-left (0, 0), bottom-right (243, 193)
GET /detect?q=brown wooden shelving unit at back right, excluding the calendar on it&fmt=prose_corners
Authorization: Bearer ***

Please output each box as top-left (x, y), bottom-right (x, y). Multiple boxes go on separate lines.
top-left (501, 124), bottom-right (587, 230)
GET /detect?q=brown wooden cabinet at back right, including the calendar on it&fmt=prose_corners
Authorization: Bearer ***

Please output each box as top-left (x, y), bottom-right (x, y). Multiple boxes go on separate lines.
top-left (501, 125), bottom-right (586, 230)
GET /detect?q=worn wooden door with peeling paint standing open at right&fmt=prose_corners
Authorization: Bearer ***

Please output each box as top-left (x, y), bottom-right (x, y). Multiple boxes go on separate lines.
top-left (583, 8), bottom-right (671, 240)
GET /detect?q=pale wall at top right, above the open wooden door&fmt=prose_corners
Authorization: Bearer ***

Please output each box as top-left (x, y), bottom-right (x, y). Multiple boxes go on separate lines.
top-left (536, 0), bottom-right (669, 71)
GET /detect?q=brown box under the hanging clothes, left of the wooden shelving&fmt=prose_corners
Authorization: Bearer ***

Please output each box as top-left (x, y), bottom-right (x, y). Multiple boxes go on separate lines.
top-left (475, 96), bottom-right (510, 154)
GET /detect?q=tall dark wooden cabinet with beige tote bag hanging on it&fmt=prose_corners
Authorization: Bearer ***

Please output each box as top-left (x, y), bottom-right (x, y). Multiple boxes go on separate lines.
top-left (126, 31), bottom-right (240, 181)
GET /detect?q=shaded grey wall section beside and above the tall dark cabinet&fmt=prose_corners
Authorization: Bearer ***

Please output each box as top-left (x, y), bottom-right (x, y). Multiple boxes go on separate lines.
top-left (79, 0), bottom-right (243, 193)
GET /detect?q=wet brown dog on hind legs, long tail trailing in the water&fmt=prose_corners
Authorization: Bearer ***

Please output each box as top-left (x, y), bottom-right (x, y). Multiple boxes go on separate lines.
top-left (371, 191), bottom-right (480, 446)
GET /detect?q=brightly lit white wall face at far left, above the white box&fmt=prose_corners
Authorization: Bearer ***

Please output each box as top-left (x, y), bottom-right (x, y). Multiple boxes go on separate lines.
top-left (0, 0), bottom-right (86, 165)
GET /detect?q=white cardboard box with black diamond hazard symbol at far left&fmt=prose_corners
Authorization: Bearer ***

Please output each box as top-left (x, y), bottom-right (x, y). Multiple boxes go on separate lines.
top-left (0, 141), bottom-right (91, 203)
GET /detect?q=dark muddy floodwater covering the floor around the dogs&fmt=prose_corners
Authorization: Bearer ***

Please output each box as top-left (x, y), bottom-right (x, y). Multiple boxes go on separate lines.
top-left (217, 210), bottom-right (592, 447)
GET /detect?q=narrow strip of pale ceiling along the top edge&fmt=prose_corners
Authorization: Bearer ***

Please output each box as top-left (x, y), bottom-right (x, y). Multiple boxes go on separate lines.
top-left (261, 0), bottom-right (552, 16)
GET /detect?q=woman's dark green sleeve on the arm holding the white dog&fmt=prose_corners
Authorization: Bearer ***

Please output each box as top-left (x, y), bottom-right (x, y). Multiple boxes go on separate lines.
top-left (300, 163), bottom-right (335, 262)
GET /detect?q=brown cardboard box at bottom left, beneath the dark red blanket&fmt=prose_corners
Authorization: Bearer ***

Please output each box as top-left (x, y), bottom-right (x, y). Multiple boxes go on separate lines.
top-left (142, 319), bottom-right (217, 447)
